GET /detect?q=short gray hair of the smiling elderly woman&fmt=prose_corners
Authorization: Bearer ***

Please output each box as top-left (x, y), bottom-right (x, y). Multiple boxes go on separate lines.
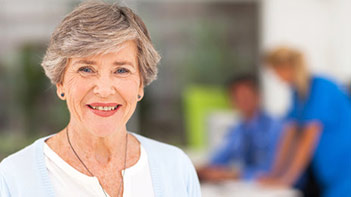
top-left (41, 1), bottom-right (160, 86)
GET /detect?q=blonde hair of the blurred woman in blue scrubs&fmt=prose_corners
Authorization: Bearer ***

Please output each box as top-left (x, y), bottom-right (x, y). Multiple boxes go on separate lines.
top-left (264, 46), bottom-right (310, 98)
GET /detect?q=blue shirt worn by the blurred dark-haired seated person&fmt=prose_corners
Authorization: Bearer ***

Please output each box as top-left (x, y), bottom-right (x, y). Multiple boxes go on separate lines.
top-left (210, 112), bottom-right (282, 179)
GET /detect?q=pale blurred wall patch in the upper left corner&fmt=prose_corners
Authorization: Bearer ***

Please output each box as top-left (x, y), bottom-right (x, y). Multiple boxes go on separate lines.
top-left (0, 0), bottom-right (72, 58)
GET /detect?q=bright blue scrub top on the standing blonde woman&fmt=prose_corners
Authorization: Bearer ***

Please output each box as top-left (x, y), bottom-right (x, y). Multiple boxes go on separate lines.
top-left (288, 77), bottom-right (351, 196)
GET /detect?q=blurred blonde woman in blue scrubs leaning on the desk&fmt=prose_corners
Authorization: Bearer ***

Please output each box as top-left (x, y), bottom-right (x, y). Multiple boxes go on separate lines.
top-left (261, 47), bottom-right (351, 197)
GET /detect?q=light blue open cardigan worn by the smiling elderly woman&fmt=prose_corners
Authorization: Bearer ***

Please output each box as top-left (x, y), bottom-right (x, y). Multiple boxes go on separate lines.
top-left (0, 134), bottom-right (201, 197)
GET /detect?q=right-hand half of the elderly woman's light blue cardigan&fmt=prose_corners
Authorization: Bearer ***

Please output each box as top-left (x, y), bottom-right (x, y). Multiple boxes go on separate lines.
top-left (133, 134), bottom-right (201, 196)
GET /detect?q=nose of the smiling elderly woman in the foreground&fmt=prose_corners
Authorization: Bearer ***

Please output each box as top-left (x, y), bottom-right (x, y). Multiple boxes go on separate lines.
top-left (93, 76), bottom-right (116, 98)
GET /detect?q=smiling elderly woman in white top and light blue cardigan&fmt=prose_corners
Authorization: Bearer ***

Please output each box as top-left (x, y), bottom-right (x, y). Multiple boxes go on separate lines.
top-left (0, 2), bottom-right (200, 197)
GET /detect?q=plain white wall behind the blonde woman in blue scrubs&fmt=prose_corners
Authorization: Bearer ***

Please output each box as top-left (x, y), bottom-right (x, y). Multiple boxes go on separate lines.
top-left (261, 0), bottom-right (351, 117)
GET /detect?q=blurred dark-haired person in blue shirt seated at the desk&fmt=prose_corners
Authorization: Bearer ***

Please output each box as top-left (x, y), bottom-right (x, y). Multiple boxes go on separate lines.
top-left (198, 74), bottom-right (282, 181)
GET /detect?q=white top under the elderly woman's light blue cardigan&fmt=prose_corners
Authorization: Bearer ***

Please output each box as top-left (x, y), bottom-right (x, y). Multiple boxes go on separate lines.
top-left (44, 143), bottom-right (154, 197)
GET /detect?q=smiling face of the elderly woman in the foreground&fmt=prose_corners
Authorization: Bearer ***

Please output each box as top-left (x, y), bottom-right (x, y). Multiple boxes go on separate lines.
top-left (57, 41), bottom-right (144, 137)
